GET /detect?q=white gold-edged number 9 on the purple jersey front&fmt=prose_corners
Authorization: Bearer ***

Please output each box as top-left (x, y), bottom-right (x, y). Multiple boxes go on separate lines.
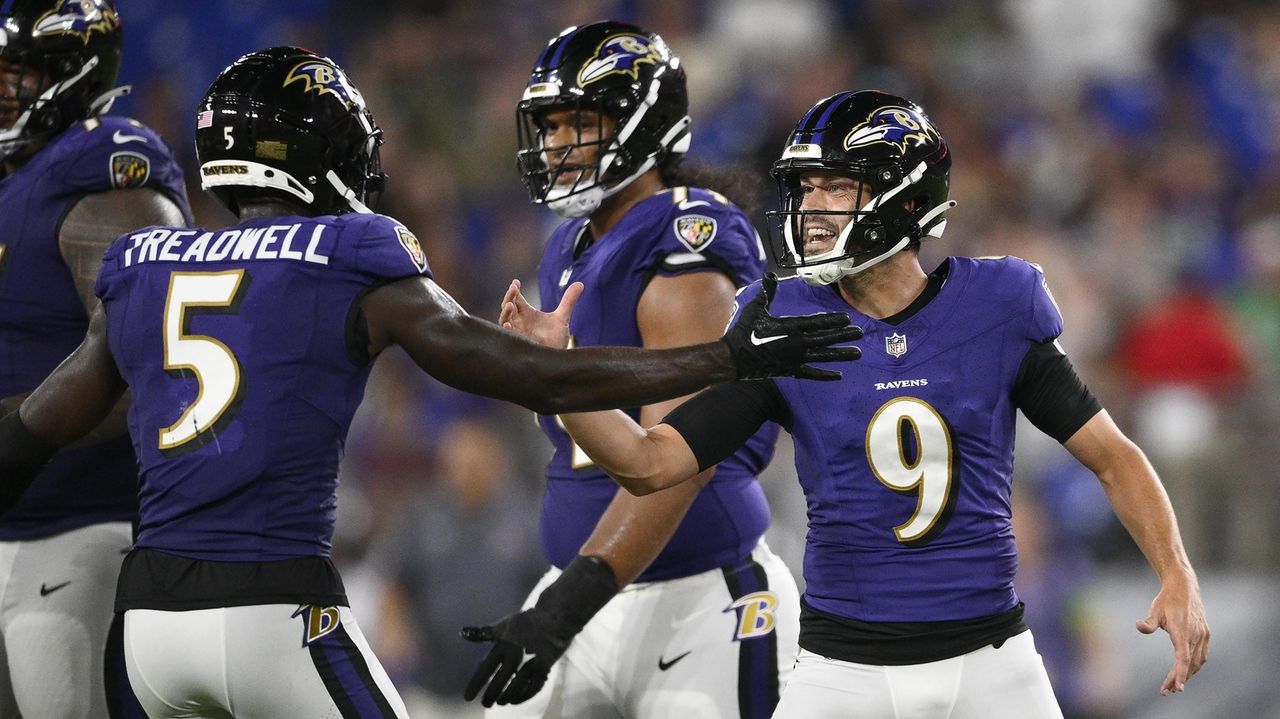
top-left (867, 397), bottom-right (957, 545)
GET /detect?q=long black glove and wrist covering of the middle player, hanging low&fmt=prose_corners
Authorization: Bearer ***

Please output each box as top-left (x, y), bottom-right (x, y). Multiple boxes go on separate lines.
top-left (462, 555), bottom-right (618, 706)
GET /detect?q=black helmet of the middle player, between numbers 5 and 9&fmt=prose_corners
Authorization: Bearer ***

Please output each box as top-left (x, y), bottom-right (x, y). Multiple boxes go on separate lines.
top-left (516, 20), bottom-right (690, 217)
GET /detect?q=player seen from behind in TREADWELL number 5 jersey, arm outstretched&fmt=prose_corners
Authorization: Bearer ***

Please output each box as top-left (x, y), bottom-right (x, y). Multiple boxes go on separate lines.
top-left (0, 47), bottom-right (858, 718)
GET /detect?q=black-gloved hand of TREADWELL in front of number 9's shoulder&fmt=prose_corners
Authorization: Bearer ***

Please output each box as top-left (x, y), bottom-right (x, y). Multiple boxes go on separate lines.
top-left (721, 273), bottom-right (863, 381)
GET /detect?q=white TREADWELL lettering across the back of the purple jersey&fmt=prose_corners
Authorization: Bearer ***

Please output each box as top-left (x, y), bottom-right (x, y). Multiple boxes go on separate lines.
top-left (124, 224), bottom-right (329, 267)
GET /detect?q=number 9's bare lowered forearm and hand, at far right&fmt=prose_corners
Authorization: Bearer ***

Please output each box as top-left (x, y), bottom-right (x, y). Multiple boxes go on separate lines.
top-left (1064, 409), bottom-right (1210, 693)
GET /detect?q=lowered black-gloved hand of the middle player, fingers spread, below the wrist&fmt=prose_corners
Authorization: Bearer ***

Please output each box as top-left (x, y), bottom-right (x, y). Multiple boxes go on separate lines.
top-left (462, 606), bottom-right (563, 706)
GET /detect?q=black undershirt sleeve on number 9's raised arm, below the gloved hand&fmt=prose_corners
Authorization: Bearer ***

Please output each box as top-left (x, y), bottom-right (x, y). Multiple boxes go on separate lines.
top-left (662, 380), bottom-right (791, 472)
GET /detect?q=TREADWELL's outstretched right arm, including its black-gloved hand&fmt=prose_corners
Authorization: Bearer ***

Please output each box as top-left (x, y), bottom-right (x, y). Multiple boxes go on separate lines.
top-left (361, 271), bottom-right (858, 415)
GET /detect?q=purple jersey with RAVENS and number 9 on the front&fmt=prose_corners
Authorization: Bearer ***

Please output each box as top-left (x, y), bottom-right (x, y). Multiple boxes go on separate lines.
top-left (739, 257), bottom-right (1062, 622)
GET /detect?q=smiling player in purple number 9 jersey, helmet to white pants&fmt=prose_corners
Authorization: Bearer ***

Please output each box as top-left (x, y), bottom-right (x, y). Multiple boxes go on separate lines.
top-left (504, 91), bottom-right (1210, 719)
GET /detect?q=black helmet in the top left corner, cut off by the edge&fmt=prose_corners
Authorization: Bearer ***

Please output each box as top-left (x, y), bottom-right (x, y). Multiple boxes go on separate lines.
top-left (0, 0), bottom-right (128, 159)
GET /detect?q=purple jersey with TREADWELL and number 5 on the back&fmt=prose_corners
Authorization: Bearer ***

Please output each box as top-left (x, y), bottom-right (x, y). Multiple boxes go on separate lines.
top-left (97, 215), bottom-right (430, 562)
